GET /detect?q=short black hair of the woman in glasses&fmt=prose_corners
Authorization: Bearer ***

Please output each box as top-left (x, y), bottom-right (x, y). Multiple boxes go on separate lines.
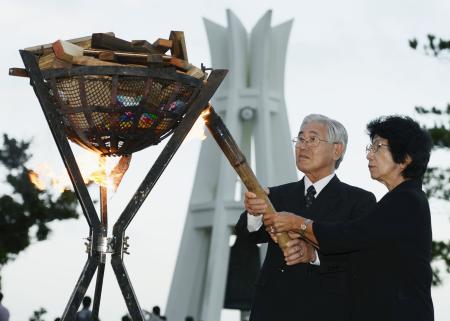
top-left (367, 116), bottom-right (432, 180)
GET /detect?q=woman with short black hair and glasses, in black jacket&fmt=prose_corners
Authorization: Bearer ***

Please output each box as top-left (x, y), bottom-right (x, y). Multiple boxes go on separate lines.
top-left (255, 116), bottom-right (434, 321)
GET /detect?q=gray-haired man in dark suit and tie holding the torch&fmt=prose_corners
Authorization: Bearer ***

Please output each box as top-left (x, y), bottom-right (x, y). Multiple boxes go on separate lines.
top-left (236, 115), bottom-right (376, 321)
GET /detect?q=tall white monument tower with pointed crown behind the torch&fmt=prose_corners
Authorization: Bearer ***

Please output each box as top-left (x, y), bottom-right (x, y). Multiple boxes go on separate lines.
top-left (166, 10), bottom-right (297, 321)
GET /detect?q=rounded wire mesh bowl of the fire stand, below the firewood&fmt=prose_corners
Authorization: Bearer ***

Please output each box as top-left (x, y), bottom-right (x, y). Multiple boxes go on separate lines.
top-left (42, 66), bottom-right (202, 156)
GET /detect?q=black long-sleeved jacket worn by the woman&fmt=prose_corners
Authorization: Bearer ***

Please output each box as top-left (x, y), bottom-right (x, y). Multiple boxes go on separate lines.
top-left (313, 180), bottom-right (434, 321)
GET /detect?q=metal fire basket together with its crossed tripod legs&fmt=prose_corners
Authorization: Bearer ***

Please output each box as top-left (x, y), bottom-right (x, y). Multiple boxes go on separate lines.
top-left (20, 50), bottom-right (227, 321)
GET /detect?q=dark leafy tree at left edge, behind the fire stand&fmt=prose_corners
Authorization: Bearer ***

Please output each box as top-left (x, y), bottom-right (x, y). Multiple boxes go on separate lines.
top-left (0, 134), bottom-right (78, 286)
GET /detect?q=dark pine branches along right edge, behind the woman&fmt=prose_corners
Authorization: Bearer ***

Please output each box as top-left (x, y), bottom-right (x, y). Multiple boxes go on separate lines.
top-left (409, 34), bottom-right (450, 285)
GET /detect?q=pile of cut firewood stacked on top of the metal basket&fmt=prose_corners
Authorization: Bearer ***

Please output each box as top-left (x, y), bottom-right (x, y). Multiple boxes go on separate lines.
top-left (10, 31), bottom-right (205, 79)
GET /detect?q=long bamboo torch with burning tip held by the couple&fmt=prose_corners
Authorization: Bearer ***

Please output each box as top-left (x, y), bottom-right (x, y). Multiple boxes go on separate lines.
top-left (203, 106), bottom-right (290, 249)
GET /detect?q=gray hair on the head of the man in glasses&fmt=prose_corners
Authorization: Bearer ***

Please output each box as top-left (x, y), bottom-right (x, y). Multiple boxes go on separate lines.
top-left (300, 114), bottom-right (348, 168)
